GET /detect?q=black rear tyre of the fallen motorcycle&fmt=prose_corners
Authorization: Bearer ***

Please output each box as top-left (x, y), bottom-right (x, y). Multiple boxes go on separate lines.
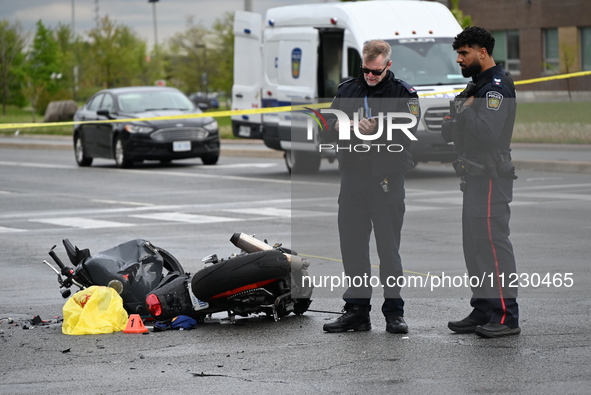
top-left (191, 250), bottom-right (291, 301)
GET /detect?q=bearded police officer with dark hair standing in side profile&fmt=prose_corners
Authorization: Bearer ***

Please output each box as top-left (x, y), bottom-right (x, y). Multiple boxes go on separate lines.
top-left (442, 26), bottom-right (521, 338)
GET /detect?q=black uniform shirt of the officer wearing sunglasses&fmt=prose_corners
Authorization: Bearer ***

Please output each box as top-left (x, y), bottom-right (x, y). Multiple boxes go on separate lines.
top-left (321, 70), bottom-right (420, 176)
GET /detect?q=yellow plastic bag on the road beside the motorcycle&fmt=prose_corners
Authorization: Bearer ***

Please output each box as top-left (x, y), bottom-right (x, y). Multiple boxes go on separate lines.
top-left (62, 286), bottom-right (127, 335)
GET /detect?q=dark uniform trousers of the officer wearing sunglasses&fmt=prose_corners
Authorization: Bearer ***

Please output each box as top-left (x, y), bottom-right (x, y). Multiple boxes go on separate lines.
top-left (338, 160), bottom-right (405, 316)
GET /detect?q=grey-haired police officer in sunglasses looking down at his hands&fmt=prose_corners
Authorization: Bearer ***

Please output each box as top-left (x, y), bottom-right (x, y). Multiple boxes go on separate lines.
top-left (321, 40), bottom-right (420, 333)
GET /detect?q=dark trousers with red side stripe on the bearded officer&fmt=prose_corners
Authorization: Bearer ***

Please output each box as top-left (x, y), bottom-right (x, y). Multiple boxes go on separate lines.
top-left (462, 175), bottom-right (519, 327)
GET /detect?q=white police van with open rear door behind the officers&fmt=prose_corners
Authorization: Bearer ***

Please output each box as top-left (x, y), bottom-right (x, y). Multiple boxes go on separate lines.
top-left (232, 0), bottom-right (468, 172)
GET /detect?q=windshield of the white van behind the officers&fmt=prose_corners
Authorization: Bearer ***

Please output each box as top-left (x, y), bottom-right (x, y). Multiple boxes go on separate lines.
top-left (388, 37), bottom-right (468, 86)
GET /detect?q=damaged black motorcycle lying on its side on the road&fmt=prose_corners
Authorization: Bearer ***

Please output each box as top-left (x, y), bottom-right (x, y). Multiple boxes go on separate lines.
top-left (44, 233), bottom-right (312, 322)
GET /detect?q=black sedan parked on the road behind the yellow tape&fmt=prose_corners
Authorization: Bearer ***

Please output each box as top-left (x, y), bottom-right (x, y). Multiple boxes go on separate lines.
top-left (74, 86), bottom-right (220, 167)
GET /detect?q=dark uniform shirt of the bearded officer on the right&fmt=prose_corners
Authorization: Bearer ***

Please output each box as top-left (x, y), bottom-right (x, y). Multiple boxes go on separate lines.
top-left (459, 64), bottom-right (516, 154)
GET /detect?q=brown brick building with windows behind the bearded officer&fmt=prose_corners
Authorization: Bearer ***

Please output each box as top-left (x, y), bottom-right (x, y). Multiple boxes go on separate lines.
top-left (444, 0), bottom-right (591, 91)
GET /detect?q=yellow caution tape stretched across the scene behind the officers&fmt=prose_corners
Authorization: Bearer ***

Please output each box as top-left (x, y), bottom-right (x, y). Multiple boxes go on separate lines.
top-left (0, 71), bottom-right (591, 130)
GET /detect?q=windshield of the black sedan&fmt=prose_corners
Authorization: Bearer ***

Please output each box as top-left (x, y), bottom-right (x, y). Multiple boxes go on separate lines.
top-left (117, 90), bottom-right (195, 112)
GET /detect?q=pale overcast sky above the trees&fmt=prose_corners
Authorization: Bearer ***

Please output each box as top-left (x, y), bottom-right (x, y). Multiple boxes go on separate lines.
top-left (0, 0), bottom-right (336, 48)
